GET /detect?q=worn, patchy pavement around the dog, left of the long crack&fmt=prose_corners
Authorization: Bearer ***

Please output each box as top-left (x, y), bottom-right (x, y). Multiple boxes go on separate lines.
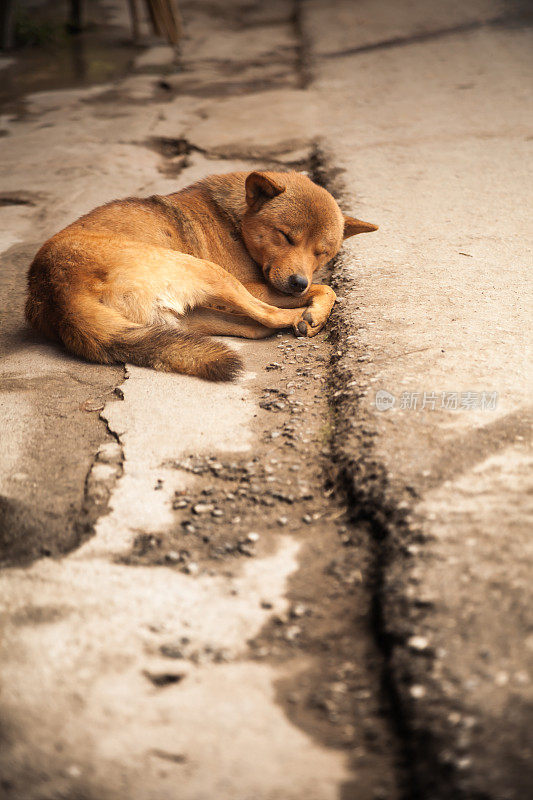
top-left (0, 3), bottom-right (390, 800)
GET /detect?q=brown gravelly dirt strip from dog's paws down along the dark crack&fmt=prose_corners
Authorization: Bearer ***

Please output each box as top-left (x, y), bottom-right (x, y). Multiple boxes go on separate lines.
top-left (121, 334), bottom-right (399, 800)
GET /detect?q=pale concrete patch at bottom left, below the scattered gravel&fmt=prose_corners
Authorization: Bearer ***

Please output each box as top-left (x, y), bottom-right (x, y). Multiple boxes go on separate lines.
top-left (2, 507), bottom-right (332, 798)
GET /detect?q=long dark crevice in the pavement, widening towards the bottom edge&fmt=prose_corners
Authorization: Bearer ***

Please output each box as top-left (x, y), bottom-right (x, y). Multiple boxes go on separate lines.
top-left (313, 147), bottom-right (483, 800)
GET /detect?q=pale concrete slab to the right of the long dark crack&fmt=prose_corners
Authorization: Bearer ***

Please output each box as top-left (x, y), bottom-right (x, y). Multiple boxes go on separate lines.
top-left (304, 2), bottom-right (533, 798)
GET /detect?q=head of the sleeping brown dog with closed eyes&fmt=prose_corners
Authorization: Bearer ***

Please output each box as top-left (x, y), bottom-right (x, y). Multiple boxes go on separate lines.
top-left (241, 172), bottom-right (377, 295)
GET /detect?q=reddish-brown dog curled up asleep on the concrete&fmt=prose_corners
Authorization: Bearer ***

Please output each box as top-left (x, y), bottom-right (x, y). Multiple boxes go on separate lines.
top-left (26, 172), bottom-right (377, 380)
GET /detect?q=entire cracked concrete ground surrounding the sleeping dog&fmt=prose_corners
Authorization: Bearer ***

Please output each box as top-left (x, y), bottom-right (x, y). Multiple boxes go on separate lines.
top-left (0, 0), bottom-right (533, 800)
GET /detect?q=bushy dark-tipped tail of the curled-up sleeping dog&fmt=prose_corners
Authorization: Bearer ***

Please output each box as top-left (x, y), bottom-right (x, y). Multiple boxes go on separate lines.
top-left (26, 294), bottom-right (242, 381)
